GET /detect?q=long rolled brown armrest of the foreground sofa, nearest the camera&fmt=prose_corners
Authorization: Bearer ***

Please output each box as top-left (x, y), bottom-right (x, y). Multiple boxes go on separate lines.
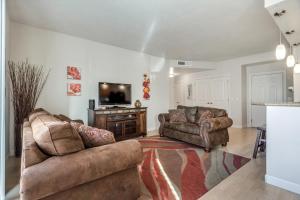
top-left (20, 140), bottom-right (143, 199)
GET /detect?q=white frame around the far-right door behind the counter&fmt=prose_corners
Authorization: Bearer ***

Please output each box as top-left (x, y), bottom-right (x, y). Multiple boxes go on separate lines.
top-left (247, 70), bottom-right (286, 127)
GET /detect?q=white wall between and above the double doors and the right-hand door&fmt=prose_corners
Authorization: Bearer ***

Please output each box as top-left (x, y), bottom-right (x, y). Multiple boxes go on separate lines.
top-left (175, 52), bottom-right (275, 127)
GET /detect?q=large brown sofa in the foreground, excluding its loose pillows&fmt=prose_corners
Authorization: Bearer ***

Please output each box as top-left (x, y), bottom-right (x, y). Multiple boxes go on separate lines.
top-left (20, 109), bottom-right (142, 200)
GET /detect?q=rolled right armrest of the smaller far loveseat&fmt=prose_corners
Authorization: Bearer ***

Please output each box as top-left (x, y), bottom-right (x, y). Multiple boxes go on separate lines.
top-left (201, 117), bottom-right (233, 132)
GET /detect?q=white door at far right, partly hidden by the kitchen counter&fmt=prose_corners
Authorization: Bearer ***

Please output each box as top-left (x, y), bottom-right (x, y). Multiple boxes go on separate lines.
top-left (250, 72), bottom-right (284, 127)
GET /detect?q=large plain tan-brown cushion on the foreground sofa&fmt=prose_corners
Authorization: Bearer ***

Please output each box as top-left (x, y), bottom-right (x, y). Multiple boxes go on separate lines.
top-left (31, 115), bottom-right (84, 156)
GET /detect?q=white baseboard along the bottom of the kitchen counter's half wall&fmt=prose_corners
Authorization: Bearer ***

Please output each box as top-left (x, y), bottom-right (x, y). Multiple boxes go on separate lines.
top-left (265, 174), bottom-right (300, 194)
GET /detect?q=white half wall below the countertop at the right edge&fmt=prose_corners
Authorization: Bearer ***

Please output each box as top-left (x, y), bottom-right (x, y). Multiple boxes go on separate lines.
top-left (265, 104), bottom-right (300, 194)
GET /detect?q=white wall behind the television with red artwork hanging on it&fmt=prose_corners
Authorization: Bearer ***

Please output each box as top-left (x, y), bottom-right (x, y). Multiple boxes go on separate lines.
top-left (10, 22), bottom-right (169, 133)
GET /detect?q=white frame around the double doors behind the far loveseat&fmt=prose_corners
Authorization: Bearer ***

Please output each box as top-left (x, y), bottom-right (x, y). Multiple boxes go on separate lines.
top-left (193, 74), bottom-right (231, 116)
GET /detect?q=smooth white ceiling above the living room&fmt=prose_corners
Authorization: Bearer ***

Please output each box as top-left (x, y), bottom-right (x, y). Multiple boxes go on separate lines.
top-left (8, 0), bottom-right (278, 61)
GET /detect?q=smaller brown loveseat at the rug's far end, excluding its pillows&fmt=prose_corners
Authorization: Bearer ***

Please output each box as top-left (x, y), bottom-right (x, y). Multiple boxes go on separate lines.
top-left (158, 106), bottom-right (232, 152)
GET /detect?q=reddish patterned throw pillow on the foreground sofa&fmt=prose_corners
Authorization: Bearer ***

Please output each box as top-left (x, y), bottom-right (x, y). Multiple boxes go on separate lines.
top-left (70, 121), bottom-right (116, 148)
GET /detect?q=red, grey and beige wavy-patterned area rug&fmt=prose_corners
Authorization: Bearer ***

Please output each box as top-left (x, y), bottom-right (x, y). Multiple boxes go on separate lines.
top-left (139, 137), bottom-right (250, 200)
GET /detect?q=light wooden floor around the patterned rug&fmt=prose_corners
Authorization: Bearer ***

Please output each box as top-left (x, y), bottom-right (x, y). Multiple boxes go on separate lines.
top-left (6, 128), bottom-right (300, 200)
